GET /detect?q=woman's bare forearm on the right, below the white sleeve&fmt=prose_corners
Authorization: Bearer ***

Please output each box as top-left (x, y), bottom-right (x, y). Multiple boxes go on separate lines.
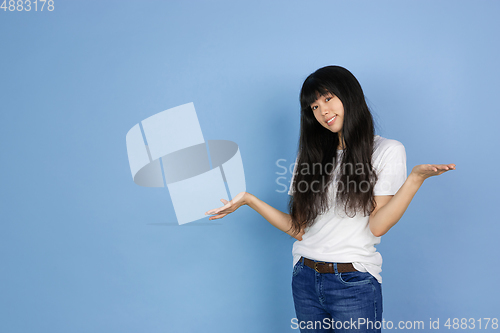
top-left (369, 173), bottom-right (423, 236)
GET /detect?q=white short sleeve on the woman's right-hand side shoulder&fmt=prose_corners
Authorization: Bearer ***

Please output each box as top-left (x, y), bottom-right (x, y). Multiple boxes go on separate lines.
top-left (373, 143), bottom-right (407, 196)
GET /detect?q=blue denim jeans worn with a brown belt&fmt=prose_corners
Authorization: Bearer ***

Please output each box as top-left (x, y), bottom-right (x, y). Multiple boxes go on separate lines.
top-left (292, 259), bottom-right (382, 333)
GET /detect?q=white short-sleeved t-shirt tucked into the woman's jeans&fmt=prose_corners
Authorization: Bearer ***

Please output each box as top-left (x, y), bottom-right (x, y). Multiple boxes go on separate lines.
top-left (288, 135), bottom-right (407, 283)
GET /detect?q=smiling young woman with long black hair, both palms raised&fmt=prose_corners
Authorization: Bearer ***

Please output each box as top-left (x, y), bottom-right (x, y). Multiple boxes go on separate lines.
top-left (206, 66), bottom-right (455, 332)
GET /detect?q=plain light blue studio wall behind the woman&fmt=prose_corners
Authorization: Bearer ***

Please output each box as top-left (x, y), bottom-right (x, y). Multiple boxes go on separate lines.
top-left (0, 0), bottom-right (500, 333)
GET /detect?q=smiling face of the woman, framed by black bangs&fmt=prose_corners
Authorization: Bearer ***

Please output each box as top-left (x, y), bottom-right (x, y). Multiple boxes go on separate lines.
top-left (311, 93), bottom-right (344, 133)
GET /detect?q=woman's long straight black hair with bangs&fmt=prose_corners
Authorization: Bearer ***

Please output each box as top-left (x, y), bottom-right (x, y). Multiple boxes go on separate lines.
top-left (288, 66), bottom-right (377, 234)
